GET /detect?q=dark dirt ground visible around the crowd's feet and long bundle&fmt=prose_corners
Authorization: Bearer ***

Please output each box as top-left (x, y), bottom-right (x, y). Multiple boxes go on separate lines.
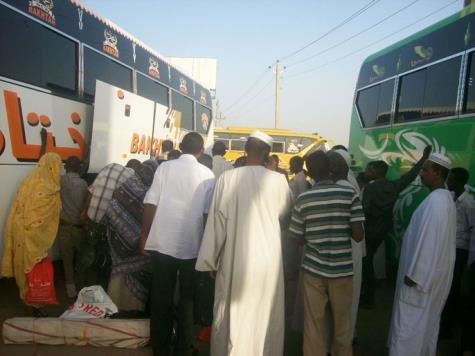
top-left (0, 268), bottom-right (456, 356)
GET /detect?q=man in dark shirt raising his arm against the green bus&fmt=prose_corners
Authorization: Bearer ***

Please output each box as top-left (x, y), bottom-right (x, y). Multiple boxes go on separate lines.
top-left (360, 146), bottom-right (432, 308)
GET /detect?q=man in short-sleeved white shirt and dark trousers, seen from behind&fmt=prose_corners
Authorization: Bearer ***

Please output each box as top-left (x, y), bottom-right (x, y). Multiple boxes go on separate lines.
top-left (140, 132), bottom-right (215, 355)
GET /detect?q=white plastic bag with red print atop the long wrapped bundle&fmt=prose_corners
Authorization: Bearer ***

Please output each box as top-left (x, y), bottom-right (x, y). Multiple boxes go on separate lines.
top-left (59, 286), bottom-right (118, 319)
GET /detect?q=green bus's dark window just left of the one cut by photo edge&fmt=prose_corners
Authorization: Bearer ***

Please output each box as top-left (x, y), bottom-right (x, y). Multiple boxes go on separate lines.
top-left (422, 57), bottom-right (460, 119)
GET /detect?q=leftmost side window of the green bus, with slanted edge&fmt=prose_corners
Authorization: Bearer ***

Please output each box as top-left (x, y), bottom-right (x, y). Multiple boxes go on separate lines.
top-left (356, 80), bottom-right (394, 127)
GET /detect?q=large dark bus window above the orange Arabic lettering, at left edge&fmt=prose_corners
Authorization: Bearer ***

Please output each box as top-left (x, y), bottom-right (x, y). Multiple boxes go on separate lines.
top-left (0, 6), bottom-right (77, 95)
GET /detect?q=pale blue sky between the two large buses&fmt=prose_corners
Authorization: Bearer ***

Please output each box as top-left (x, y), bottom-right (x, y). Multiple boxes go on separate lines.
top-left (81, 0), bottom-right (463, 145)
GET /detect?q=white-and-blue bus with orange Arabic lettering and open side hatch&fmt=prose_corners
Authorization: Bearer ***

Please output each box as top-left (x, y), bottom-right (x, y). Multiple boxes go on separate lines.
top-left (0, 0), bottom-right (212, 262)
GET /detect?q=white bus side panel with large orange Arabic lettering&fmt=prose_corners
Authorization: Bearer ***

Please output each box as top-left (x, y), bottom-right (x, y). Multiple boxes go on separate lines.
top-left (0, 81), bottom-right (92, 163)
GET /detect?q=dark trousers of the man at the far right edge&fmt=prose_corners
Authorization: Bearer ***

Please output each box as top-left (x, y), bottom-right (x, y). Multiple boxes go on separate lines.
top-left (441, 248), bottom-right (468, 332)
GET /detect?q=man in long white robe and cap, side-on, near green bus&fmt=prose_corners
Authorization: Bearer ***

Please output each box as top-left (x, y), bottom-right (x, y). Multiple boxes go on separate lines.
top-left (388, 153), bottom-right (456, 356)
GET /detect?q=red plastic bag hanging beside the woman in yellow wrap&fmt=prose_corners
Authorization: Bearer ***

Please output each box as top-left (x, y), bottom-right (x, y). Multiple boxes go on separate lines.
top-left (24, 257), bottom-right (58, 304)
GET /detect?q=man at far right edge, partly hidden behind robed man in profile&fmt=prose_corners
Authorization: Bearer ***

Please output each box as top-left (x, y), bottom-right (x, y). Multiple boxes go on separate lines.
top-left (439, 167), bottom-right (475, 338)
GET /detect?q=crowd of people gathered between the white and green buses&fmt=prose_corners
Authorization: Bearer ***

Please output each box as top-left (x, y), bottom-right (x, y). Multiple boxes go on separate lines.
top-left (1, 131), bottom-right (475, 356)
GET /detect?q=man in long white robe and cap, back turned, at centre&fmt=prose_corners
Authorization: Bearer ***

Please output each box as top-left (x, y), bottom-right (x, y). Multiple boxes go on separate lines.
top-left (196, 132), bottom-right (292, 356)
